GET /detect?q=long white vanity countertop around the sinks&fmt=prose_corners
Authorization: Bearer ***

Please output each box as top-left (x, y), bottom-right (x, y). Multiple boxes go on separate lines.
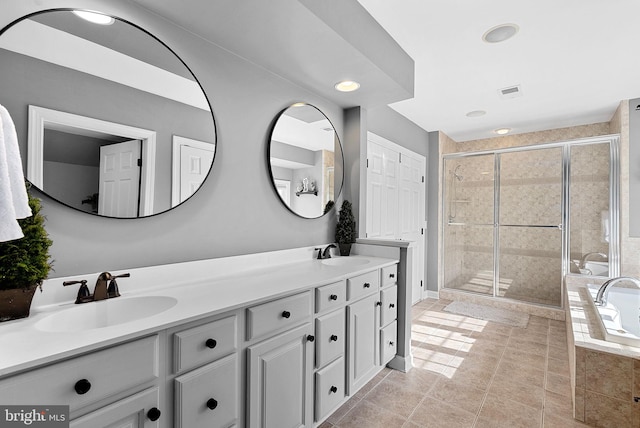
top-left (0, 252), bottom-right (398, 376)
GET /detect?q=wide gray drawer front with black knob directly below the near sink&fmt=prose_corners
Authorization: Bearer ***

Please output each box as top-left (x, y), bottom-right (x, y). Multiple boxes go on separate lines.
top-left (0, 336), bottom-right (158, 413)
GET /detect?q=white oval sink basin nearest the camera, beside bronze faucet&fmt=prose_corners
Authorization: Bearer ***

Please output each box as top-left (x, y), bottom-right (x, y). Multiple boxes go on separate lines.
top-left (35, 296), bottom-right (178, 332)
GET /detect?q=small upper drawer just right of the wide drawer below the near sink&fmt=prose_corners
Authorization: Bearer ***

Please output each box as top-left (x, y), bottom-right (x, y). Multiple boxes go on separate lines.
top-left (173, 315), bottom-right (238, 373)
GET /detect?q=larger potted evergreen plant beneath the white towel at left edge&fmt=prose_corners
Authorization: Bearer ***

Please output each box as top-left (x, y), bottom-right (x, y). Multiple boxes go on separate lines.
top-left (0, 187), bottom-right (52, 322)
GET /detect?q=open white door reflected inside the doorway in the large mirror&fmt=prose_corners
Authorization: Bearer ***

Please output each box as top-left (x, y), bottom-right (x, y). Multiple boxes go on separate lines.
top-left (98, 140), bottom-right (142, 218)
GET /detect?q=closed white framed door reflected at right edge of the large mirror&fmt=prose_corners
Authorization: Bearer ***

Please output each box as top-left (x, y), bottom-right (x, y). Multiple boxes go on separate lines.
top-left (171, 135), bottom-right (215, 206)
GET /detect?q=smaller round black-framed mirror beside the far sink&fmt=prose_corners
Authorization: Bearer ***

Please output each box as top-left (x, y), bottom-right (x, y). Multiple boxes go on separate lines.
top-left (269, 103), bottom-right (344, 218)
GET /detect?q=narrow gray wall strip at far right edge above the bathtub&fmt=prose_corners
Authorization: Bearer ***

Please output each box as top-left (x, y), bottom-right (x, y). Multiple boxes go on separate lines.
top-left (629, 98), bottom-right (640, 237)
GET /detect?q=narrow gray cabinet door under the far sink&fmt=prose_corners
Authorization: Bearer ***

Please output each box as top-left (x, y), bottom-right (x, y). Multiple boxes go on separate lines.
top-left (347, 294), bottom-right (378, 395)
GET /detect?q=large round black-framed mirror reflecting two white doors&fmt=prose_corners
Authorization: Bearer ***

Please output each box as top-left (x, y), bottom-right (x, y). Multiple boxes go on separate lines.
top-left (0, 10), bottom-right (216, 218)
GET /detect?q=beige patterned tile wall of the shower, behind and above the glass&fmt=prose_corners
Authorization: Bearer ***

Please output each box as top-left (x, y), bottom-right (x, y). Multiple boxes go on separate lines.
top-left (440, 123), bottom-right (611, 306)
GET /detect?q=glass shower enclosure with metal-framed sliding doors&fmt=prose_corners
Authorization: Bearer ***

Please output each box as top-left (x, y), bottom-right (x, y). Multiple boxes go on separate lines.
top-left (441, 136), bottom-right (619, 308)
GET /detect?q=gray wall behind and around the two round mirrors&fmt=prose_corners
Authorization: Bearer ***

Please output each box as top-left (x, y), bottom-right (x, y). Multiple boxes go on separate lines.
top-left (0, 0), bottom-right (348, 281)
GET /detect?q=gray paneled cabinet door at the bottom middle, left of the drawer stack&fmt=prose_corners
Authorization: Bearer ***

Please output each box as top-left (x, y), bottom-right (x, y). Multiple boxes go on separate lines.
top-left (247, 323), bottom-right (313, 428)
